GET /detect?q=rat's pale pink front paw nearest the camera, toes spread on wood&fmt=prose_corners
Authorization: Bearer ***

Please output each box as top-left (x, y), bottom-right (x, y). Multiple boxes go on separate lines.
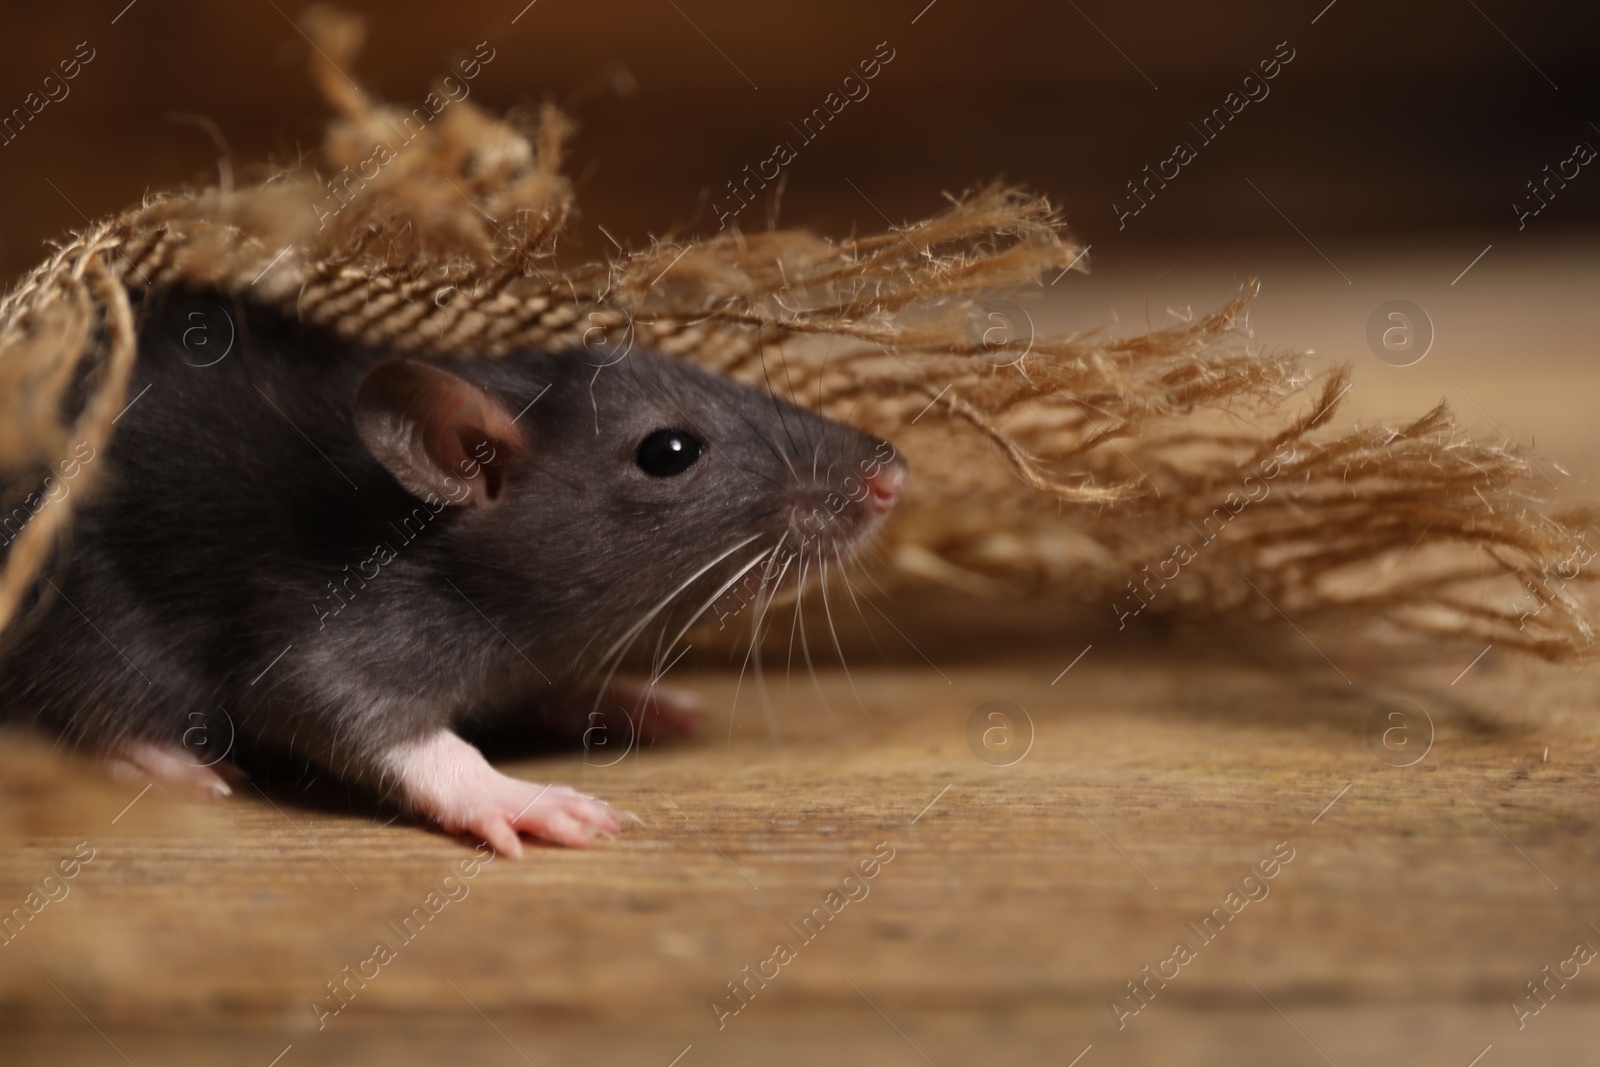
top-left (387, 729), bottom-right (624, 856)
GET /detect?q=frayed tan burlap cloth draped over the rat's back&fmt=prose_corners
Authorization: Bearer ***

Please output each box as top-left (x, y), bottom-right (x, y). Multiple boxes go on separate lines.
top-left (0, 10), bottom-right (1595, 659)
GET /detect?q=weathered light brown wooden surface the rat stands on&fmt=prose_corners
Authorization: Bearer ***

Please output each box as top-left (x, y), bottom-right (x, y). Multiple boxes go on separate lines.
top-left (0, 242), bottom-right (1600, 1067)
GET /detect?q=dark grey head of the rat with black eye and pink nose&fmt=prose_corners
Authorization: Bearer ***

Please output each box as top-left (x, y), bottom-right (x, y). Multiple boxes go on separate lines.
top-left (355, 352), bottom-right (907, 668)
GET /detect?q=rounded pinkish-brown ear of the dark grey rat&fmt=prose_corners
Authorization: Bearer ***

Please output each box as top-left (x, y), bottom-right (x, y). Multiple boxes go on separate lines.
top-left (355, 360), bottom-right (526, 507)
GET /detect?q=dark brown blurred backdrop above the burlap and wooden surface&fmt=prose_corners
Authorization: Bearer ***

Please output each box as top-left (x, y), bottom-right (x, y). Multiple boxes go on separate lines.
top-left (0, 0), bottom-right (1600, 278)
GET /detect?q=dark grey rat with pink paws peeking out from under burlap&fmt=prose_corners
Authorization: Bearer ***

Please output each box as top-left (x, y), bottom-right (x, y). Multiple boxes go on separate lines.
top-left (0, 287), bottom-right (906, 854)
